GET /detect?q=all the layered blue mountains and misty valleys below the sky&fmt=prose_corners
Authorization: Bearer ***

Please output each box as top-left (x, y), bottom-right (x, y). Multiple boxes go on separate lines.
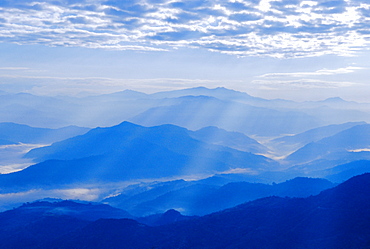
top-left (0, 87), bottom-right (370, 249)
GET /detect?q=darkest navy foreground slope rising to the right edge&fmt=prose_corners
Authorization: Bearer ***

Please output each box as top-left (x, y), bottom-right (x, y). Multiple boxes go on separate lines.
top-left (23, 174), bottom-right (370, 249)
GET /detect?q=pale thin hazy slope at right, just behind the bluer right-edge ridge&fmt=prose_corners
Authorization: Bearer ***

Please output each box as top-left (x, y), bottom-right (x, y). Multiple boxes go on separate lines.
top-left (268, 122), bottom-right (365, 154)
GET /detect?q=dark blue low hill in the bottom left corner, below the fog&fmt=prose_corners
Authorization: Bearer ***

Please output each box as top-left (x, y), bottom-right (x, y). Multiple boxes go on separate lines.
top-left (0, 201), bottom-right (132, 248)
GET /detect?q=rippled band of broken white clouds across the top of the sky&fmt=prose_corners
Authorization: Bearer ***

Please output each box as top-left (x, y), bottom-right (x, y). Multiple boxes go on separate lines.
top-left (0, 0), bottom-right (370, 58)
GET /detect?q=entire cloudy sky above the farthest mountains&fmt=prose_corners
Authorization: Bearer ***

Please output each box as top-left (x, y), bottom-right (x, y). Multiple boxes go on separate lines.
top-left (0, 0), bottom-right (370, 102)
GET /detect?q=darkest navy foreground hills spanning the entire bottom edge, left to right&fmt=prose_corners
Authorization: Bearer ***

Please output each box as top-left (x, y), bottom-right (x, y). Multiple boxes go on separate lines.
top-left (0, 174), bottom-right (370, 249)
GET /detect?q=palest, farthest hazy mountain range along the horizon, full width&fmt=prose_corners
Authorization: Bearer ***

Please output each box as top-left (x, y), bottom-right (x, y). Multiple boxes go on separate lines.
top-left (0, 87), bottom-right (370, 137)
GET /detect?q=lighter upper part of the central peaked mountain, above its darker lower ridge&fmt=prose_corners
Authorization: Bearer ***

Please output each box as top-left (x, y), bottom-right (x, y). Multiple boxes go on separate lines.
top-left (26, 122), bottom-right (274, 167)
